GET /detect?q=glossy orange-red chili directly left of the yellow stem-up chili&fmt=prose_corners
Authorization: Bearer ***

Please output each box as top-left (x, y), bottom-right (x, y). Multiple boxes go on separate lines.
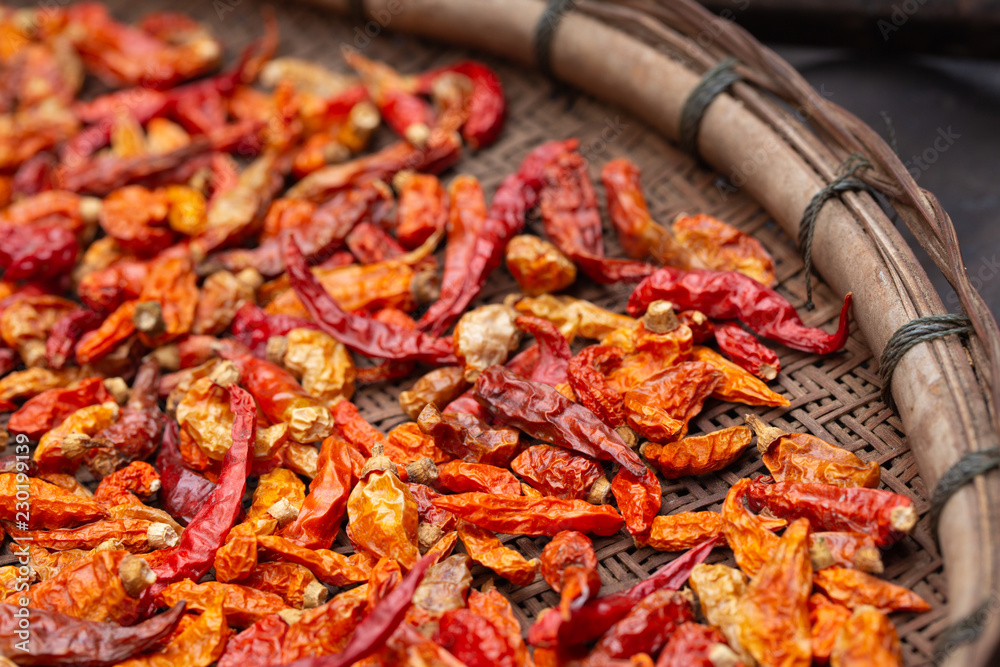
top-left (282, 435), bottom-right (354, 549)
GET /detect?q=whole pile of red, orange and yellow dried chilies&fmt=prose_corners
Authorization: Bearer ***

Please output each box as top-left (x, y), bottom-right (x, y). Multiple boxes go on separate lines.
top-left (0, 3), bottom-right (928, 667)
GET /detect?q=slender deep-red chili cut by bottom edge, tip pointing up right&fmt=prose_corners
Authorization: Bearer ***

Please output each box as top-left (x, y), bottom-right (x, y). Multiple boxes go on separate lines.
top-left (288, 554), bottom-right (437, 667)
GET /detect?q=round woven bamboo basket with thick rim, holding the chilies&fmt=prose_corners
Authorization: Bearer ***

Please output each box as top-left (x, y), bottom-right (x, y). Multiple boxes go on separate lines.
top-left (84, 0), bottom-right (1000, 666)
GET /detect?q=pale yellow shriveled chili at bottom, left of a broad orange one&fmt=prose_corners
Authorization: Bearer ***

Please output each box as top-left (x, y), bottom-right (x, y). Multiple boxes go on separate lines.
top-left (689, 563), bottom-right (756, 665)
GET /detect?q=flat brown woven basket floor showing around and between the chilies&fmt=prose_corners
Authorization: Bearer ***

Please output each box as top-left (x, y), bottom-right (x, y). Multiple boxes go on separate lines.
top-left (76, 0), bottom-right (946, 665)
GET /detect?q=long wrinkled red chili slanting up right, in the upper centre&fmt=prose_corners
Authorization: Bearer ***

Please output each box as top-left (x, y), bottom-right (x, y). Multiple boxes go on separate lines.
top-left (417, 139), bottom-right (577, 336)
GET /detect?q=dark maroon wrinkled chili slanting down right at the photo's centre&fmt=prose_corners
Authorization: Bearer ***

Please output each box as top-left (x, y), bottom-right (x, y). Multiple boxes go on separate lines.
top-left (476, 366), bottom-right (646, 475)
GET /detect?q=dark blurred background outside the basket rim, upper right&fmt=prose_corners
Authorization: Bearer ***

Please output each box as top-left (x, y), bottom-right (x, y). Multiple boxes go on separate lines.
top-left (704, 0), bottom-right (1000, 315)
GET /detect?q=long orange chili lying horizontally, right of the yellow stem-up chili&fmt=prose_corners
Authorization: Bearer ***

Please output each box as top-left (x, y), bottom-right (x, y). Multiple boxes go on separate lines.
top-left (434, 492), bottom-right (623, 535)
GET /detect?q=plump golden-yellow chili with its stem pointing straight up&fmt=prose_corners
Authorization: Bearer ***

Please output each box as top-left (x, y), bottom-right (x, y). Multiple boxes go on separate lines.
top-left (347, 444), bottom-right (420, 568)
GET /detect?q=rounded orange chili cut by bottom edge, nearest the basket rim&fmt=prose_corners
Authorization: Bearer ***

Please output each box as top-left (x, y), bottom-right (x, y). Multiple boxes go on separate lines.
top-left (830, 607), bottom-right (903, 667)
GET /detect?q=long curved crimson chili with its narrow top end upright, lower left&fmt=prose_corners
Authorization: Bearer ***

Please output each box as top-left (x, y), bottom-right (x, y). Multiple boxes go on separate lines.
top-left (143, 385), bottom-right (257, 611)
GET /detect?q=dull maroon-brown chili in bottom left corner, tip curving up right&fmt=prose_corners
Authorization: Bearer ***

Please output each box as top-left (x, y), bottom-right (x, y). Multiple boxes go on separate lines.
top-left (0, 602), bottom-right (184, 667)
